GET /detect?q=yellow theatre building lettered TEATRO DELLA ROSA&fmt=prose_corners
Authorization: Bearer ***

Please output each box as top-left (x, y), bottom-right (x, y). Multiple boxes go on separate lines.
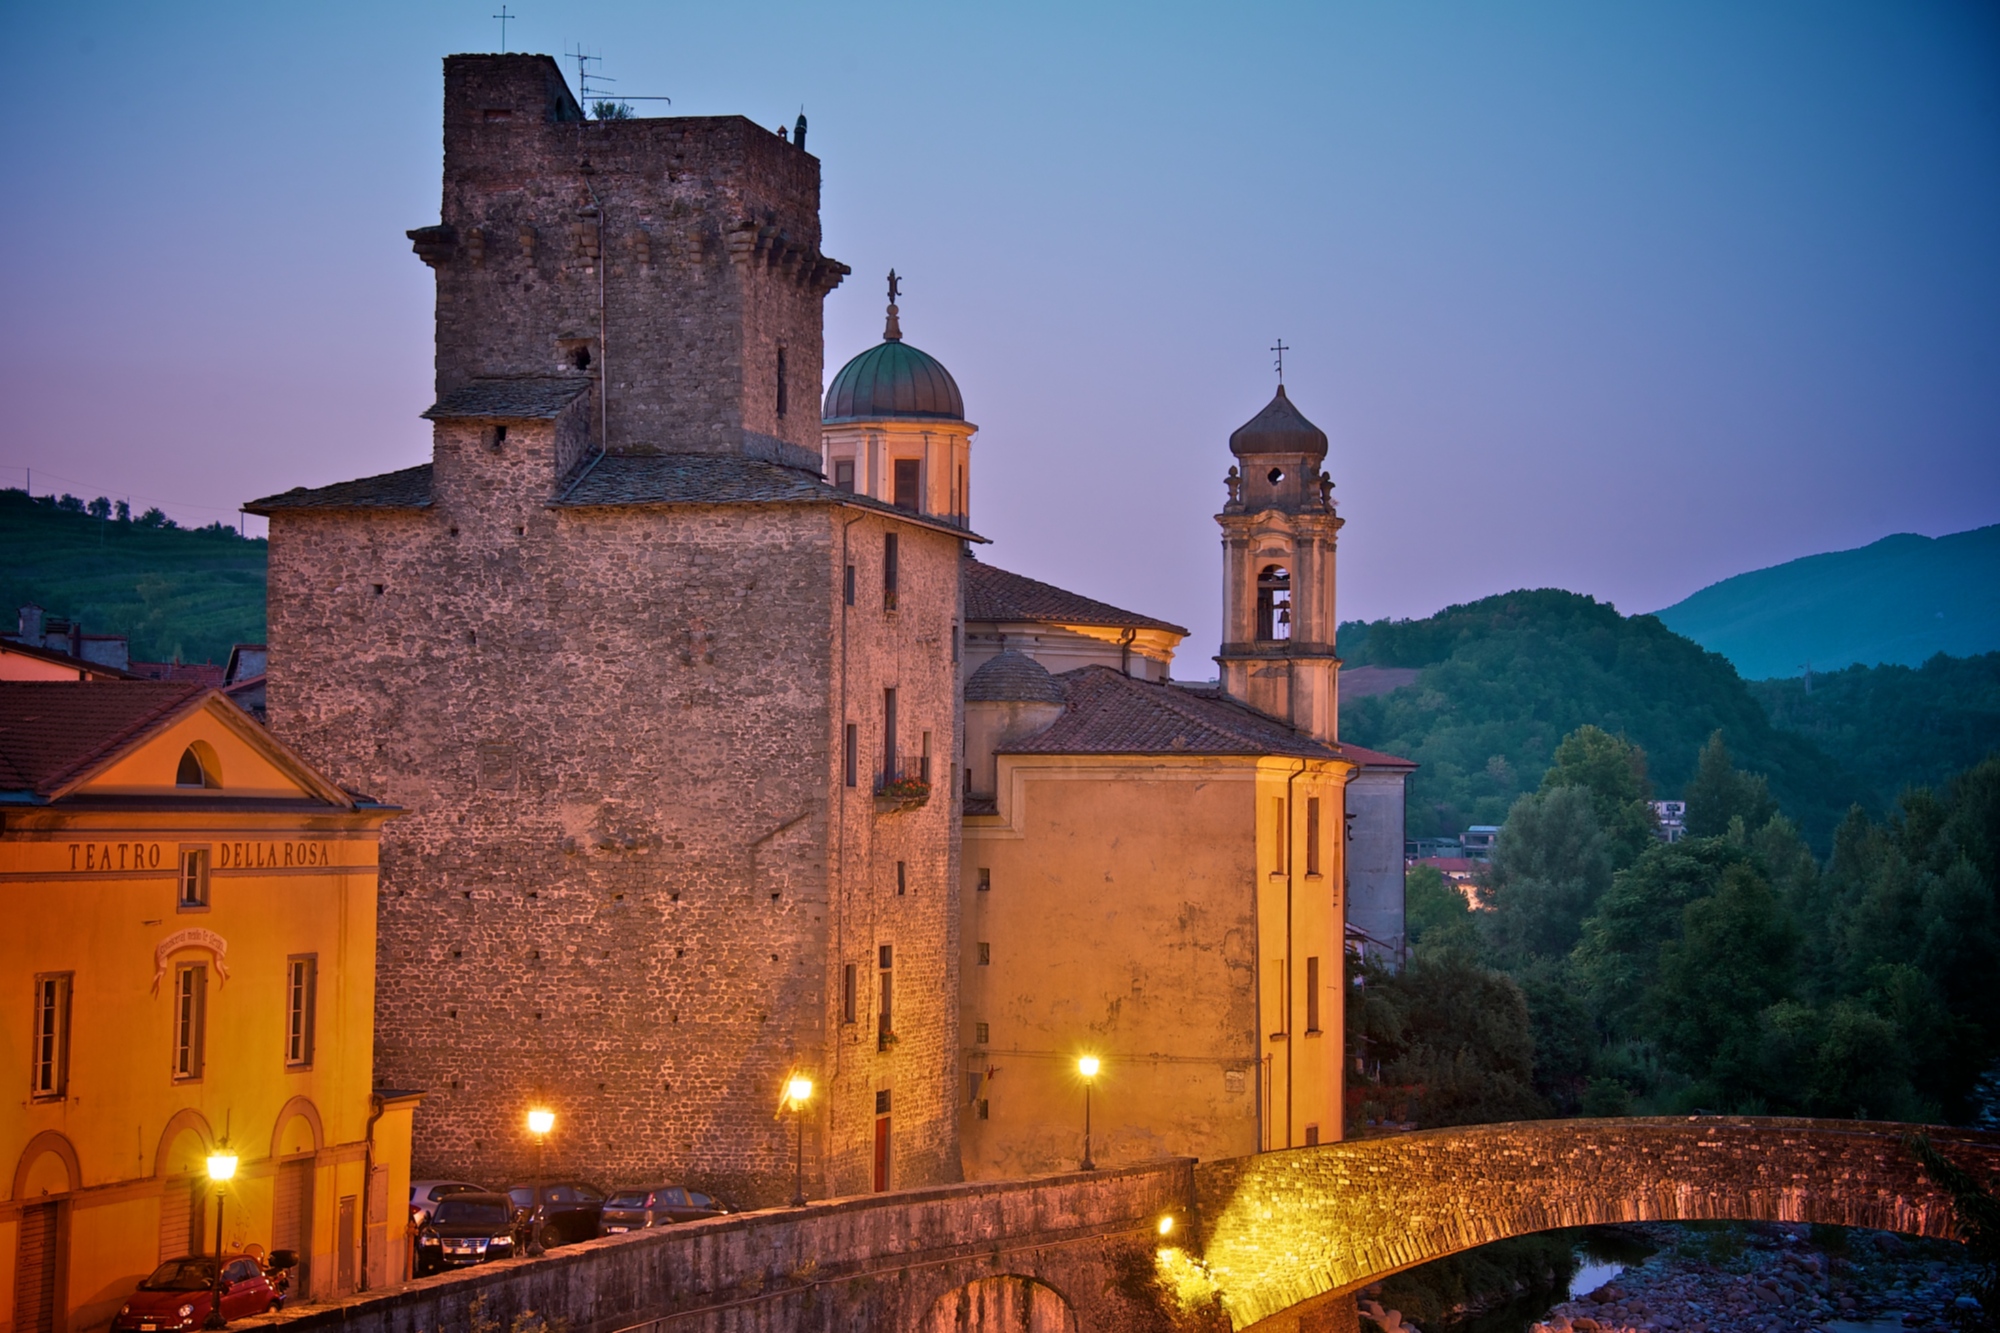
top-left (0, 681), bottom-right (418, 1333)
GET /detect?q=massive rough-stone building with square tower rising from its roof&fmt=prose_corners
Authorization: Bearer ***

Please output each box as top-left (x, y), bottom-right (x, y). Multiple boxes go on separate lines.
top-left (252, 56), bottom-right (970, 1205)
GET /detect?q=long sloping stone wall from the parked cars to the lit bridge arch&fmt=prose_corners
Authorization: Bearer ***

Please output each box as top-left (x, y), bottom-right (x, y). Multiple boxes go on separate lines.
top-left (248, 1161), bottom-right (1192, 1333)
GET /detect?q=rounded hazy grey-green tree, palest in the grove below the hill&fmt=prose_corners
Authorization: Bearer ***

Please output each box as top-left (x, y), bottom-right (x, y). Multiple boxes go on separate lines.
top-left (1484, 787), bottom-right (1612, 965)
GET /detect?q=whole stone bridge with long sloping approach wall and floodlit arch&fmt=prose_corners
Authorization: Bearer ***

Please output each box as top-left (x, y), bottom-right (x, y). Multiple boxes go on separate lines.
top-left (252, 1117), bottom-right (2000, 1333)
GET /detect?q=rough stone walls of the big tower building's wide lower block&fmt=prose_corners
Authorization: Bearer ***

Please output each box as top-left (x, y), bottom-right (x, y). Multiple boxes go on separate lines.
top-left (270, 474), bottom-right (958, 1201)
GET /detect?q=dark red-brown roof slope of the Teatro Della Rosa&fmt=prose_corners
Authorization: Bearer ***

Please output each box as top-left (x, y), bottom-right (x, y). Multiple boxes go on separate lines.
top-left (0, 681), bottom-right (208, 799)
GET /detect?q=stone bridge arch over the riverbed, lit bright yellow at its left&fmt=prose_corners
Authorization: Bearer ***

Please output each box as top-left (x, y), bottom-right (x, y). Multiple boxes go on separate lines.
top-left (1194, 1117), bottom-right (2000, 1329)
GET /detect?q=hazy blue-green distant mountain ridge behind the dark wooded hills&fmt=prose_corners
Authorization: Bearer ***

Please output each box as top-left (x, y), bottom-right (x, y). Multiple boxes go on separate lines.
top-left (1654, 524), bottom-right (2000, 681)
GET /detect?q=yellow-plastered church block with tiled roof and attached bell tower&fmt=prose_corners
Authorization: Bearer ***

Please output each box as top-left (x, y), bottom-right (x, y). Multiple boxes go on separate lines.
top-left (960, 386), bottom-right (1414, 1179)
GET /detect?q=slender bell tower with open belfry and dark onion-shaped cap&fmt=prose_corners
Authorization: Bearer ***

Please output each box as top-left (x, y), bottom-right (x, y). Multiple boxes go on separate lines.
top-left (1216, 380), bottom-right (1342, 745)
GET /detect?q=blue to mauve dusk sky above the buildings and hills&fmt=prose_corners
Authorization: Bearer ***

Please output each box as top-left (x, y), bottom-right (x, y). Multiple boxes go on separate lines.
top-left (0, 0), bottom-right (2000, 664)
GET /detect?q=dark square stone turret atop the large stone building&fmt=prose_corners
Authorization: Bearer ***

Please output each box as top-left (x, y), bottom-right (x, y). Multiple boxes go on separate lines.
top-left (430, 56), bottom-right (846, 462)
